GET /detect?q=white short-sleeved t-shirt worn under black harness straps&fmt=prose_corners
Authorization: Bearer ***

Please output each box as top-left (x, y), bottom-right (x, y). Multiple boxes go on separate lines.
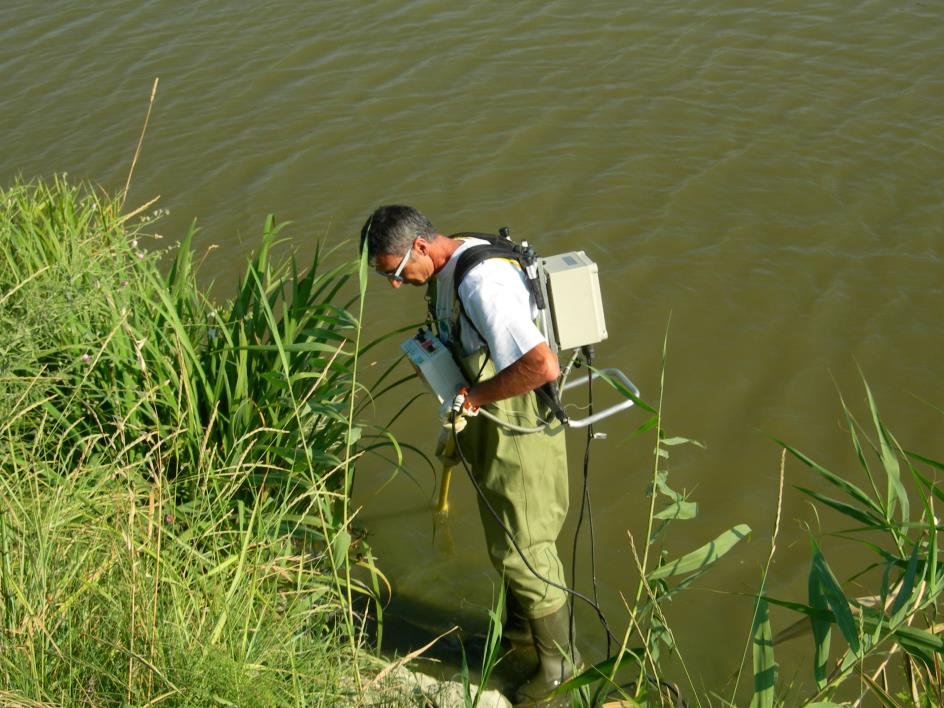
top-left (436, 237), bottom-right (547, 371)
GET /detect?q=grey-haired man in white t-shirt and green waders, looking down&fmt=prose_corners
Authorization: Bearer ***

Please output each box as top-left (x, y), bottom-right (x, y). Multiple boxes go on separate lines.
top-left (361, 205), bottom-right (579, 705)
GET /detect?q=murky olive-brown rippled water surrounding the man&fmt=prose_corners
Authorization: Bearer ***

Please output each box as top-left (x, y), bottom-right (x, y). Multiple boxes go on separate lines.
top-left (0, 0), bottom-right (944, 691)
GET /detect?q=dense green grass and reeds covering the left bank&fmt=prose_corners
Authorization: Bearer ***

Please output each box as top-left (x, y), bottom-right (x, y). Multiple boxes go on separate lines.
top-left (0, 179), bottom-right (379, 705)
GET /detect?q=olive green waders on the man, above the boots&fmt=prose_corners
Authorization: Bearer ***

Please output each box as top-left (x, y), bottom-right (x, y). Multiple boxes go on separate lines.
top-left (458, 352), bottom-right (568, 619)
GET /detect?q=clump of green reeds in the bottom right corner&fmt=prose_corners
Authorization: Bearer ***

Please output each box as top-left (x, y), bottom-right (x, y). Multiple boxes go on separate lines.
top-left (752, 380), bottom-right (944, 706)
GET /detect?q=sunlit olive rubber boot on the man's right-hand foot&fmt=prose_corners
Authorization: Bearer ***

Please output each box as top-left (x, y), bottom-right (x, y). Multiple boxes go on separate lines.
top-left (515, 604), bottom-right (580, 708)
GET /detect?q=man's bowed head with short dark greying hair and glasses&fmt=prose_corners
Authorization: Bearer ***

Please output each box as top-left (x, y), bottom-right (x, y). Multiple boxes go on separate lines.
top-left (361, 204), bottom-right (439, 287)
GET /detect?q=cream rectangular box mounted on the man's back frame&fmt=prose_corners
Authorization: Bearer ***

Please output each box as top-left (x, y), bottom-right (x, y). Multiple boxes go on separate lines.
top-left (541, 251), bottom-right (607, 350)
